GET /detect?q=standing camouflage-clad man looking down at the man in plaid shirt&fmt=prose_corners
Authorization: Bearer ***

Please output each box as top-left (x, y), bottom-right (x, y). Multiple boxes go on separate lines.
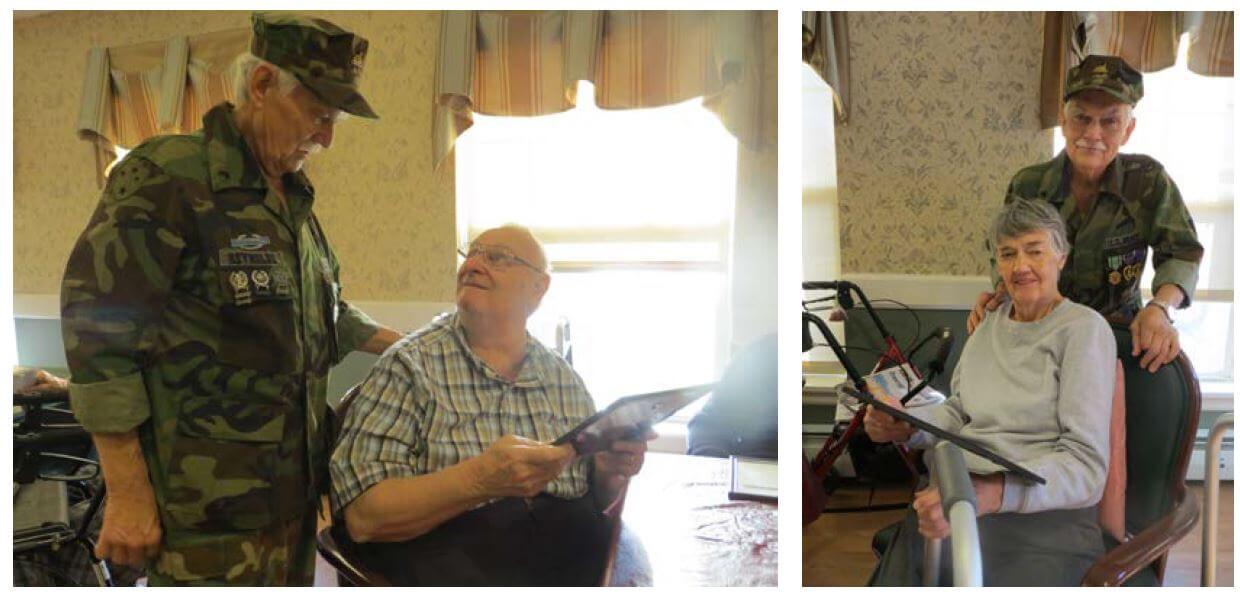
top-left (61, 14), bottom-right (399, 584)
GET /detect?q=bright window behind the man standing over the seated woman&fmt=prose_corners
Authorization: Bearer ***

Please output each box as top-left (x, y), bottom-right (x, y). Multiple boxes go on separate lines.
top-left (1054, 40), bottom-right (1235, 383)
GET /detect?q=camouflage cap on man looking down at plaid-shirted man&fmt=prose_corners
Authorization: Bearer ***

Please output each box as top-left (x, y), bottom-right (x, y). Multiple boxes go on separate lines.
top-left (249, 12), bottom-right (379, 118)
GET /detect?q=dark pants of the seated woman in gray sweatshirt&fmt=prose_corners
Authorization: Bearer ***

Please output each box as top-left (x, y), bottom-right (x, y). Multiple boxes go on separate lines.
top-left (869, 506), bottom-right (1104, 586)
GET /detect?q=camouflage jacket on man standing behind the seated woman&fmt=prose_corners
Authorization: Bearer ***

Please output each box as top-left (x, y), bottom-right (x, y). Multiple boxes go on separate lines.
top-left (1006, 151), bottom-right (1203, 320)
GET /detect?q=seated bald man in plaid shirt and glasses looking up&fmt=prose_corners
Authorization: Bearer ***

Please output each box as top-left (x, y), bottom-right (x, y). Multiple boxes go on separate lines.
top-left (331, 226), bottom-right (647, 586)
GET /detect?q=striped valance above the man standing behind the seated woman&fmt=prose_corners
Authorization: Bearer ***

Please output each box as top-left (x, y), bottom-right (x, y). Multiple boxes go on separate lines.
top-left (1040, 11), bottom-right (1235, 127)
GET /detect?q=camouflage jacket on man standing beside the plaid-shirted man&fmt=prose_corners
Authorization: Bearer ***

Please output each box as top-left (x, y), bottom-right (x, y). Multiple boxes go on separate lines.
top-left (61, 104), bottom-right (377, 531)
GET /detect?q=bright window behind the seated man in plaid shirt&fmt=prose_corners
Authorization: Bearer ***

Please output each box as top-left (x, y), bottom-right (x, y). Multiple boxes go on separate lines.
top-left (456, 82), bottom-right (737, 407)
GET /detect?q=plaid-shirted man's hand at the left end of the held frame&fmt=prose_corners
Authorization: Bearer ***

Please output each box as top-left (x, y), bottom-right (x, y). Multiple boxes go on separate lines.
top-left (470, 434), bottom-right (577, 499)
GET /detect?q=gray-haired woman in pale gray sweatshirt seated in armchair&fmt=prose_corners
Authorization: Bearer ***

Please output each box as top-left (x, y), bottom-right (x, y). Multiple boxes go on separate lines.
top-left (866, 200), bottom-right (1116, 586)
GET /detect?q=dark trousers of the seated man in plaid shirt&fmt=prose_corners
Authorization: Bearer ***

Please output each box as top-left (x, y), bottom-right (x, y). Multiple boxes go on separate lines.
top-left (353, 494), bottom-right (610, 586)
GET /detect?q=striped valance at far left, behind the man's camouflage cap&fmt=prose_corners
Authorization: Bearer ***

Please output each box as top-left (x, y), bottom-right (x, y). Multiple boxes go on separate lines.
top-left (77, 29), bottom-right (249, 186)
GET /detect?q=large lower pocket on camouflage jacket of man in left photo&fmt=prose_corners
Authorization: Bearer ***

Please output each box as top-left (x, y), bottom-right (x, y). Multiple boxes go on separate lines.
top-left (165, 396), bottom-right (291, 531)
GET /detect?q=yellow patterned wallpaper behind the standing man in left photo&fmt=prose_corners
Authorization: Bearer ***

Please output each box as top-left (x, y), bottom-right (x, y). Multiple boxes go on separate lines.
top-left (12, 11), bottom-right (456, 301)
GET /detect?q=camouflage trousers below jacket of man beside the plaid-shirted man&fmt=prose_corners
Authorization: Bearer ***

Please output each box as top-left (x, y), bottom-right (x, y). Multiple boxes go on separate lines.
top-left (148, 510), bottom-right (316, 586)
